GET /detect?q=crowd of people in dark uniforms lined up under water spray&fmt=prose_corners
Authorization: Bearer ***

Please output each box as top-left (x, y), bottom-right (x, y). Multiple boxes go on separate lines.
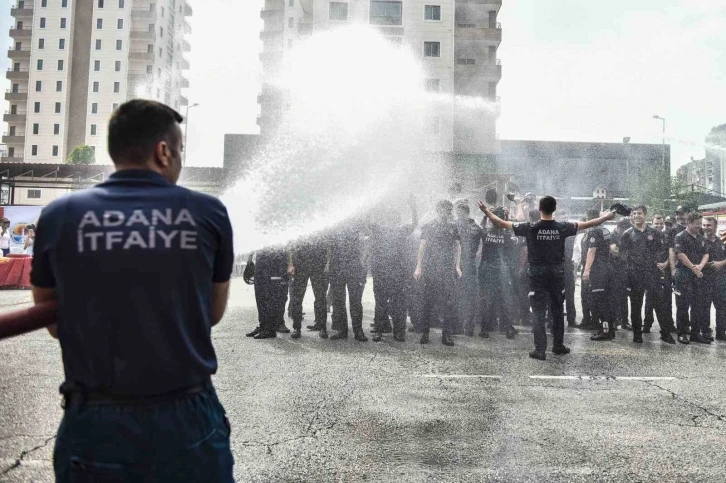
top-left (247, 191), bottom-right (726, 356)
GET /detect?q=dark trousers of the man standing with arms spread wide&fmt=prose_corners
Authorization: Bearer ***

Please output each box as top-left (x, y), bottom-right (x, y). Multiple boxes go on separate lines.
top-left (528, 265), bottom-right (565, 352)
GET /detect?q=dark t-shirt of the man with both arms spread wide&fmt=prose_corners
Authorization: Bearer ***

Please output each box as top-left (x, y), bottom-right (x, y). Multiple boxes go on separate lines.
top-left (514, 220), bottom-right (577, 265)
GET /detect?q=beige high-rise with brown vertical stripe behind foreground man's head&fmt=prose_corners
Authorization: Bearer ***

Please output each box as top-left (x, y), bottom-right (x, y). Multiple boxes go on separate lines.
top-left (2, 0), bottom-right (192, 164)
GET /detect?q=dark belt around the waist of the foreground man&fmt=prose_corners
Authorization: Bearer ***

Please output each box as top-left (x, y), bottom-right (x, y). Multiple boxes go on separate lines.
top-left (61, 379), bottom-right (213, 409)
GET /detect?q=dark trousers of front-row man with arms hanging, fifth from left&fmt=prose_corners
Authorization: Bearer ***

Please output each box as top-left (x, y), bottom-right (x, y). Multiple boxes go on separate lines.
top-left (421, 273), bottom-right (457, 335)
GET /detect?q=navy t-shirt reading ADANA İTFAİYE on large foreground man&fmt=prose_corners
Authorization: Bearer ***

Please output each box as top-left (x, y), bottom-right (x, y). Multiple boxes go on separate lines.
top-left (31, 170), bottom-right (234, 396)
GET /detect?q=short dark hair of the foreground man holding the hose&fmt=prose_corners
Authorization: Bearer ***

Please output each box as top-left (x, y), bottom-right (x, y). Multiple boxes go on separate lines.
top-left (108, 99), bottom-right (184, 164)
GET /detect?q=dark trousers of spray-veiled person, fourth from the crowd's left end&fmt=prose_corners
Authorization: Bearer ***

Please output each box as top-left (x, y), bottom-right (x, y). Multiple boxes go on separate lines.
top-left (372, 266), bottom-right (406, 336)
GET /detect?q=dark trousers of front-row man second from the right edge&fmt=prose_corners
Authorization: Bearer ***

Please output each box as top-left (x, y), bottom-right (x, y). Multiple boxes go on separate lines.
top-left (675, 267), bottom-right (710, 335)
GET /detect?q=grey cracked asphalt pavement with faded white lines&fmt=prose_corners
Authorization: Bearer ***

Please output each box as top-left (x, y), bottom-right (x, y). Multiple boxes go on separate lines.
top-left (0, 281), bottom-right (726, 482)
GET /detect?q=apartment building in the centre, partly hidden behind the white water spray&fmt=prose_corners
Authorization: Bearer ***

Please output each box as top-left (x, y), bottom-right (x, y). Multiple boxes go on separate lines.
top-left (258, 0), bottom-right (502, 155)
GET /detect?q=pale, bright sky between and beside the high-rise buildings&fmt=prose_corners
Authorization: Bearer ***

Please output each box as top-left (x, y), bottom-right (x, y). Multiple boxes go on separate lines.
top-left (0, 0), bottom-right (726, 171)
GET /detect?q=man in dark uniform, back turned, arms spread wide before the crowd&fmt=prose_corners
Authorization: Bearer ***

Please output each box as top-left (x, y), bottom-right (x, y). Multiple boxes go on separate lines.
top-left (479, 196), bottom-right (615, 360)
